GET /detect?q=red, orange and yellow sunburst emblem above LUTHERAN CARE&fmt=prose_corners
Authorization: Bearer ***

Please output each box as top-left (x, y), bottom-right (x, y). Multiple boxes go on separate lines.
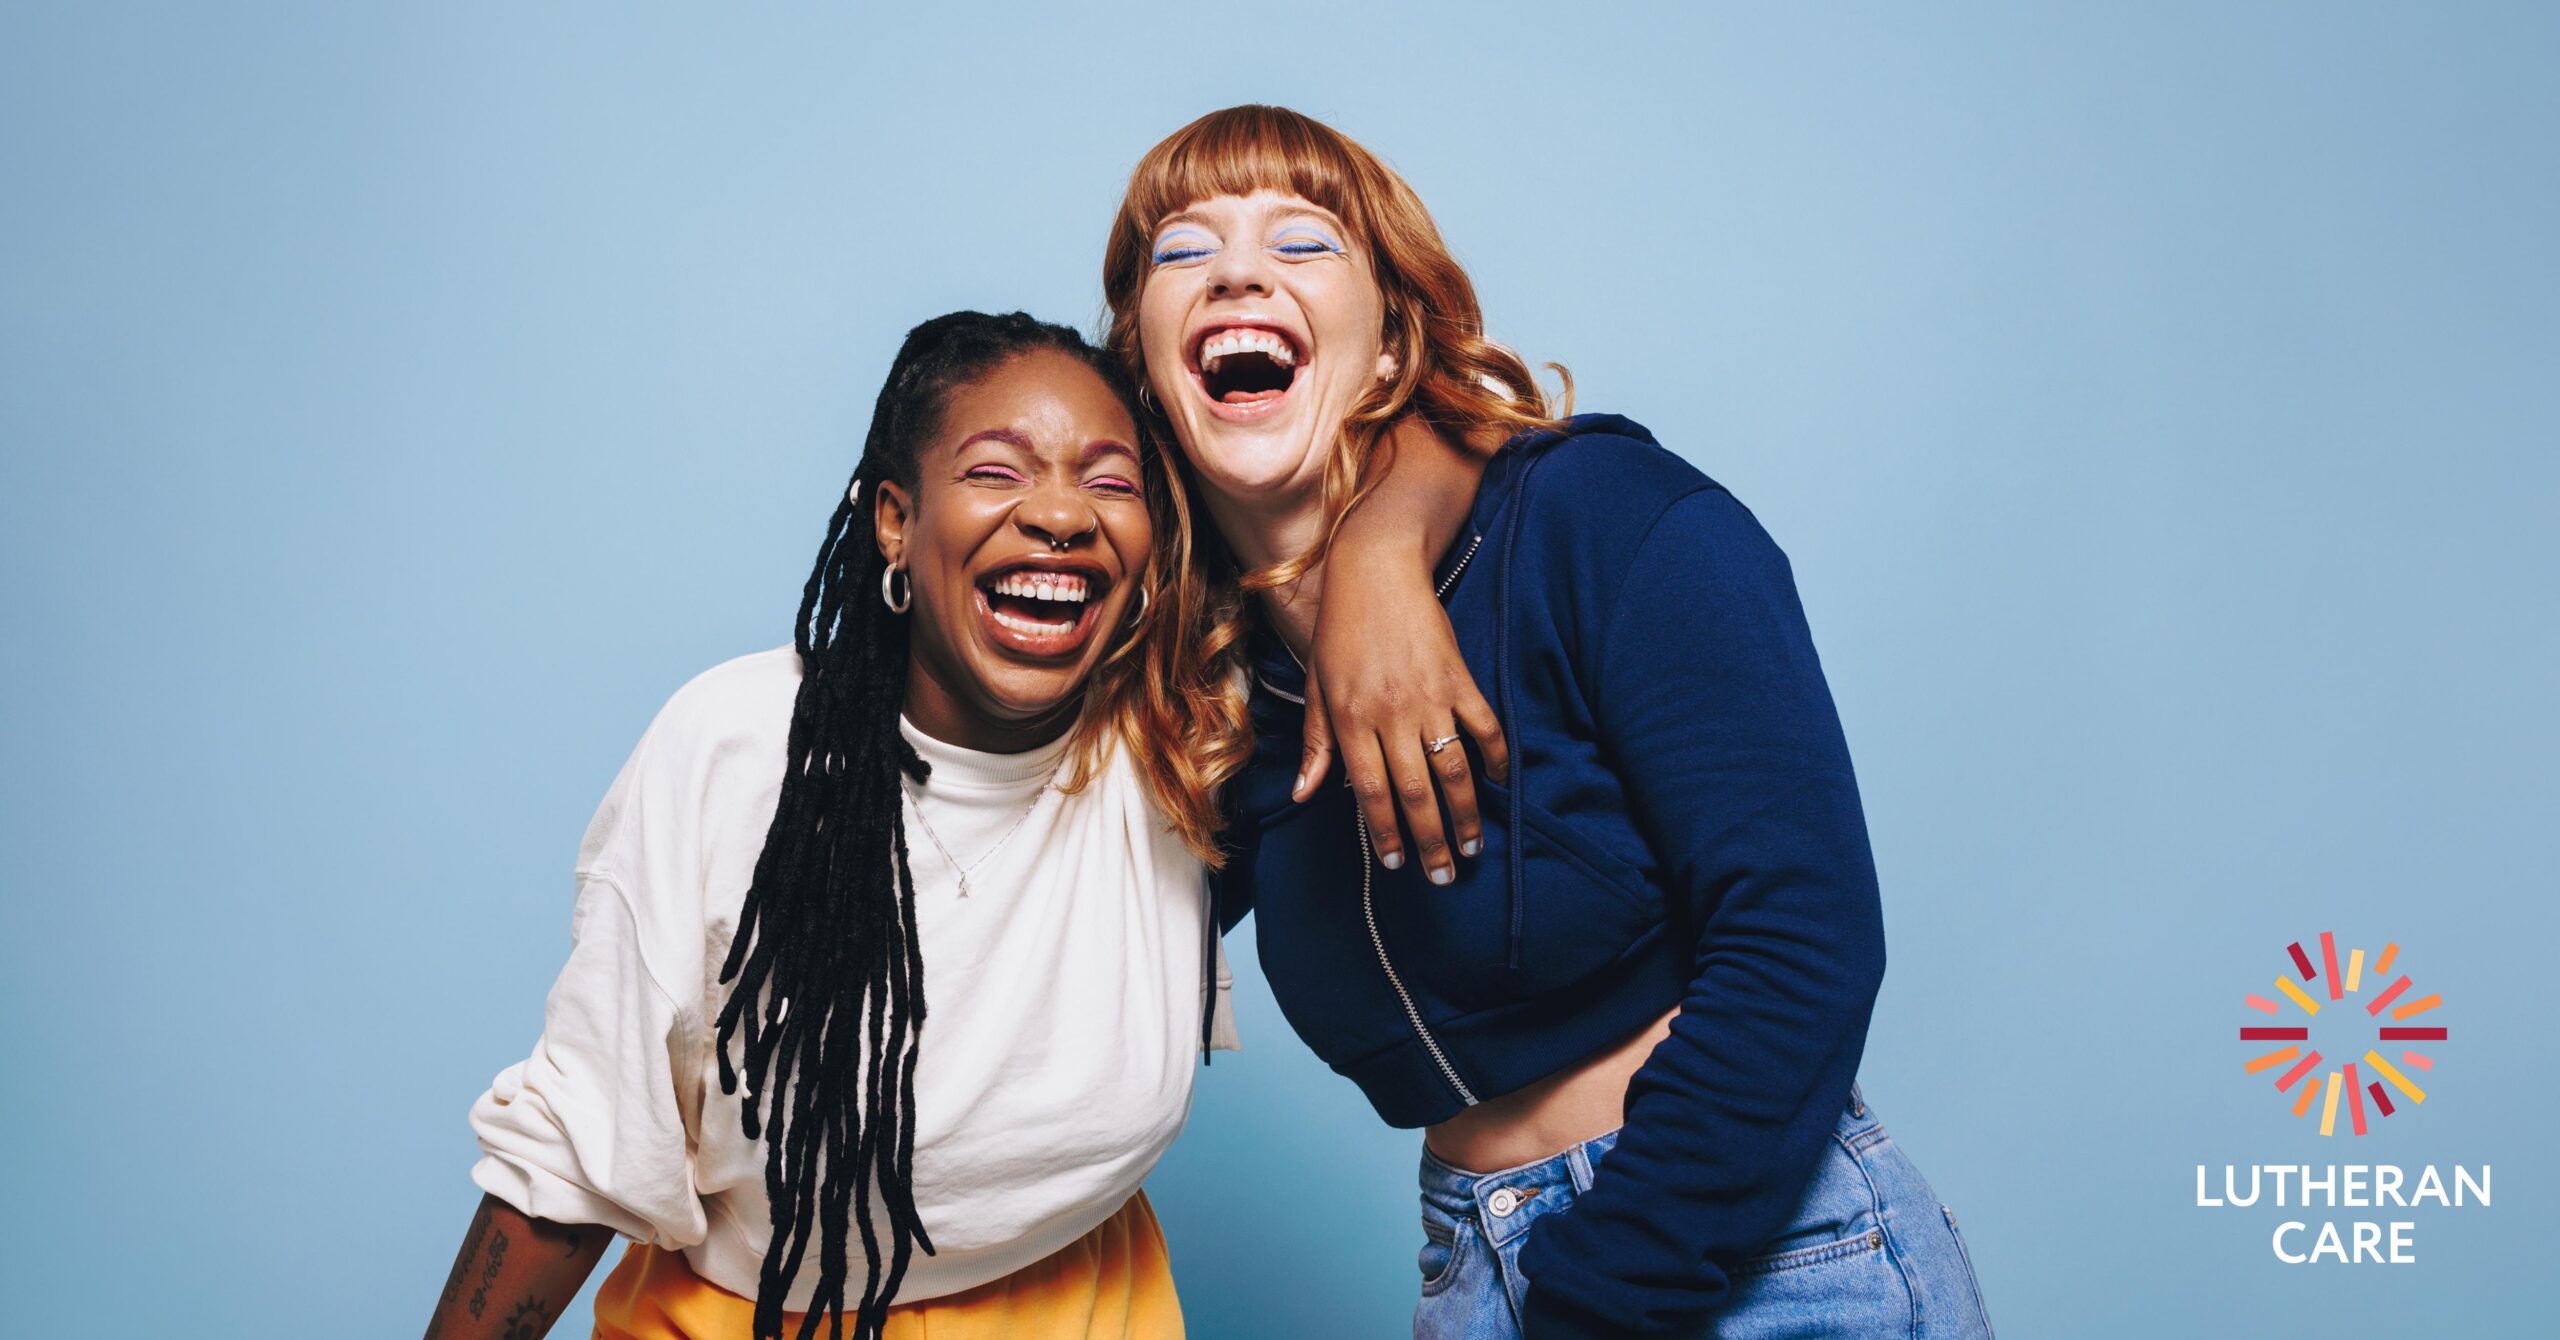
top-left (2240, 930), bottom-right (2445, 1135)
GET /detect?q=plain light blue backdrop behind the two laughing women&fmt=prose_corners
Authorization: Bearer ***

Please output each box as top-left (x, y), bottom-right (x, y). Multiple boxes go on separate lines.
top-left (0, 0), bottom-right (2560, 1337)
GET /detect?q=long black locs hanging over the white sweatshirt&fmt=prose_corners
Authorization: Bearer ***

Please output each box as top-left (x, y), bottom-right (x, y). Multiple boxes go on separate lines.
top-left (717, 313), bottom-right (1139, 1340)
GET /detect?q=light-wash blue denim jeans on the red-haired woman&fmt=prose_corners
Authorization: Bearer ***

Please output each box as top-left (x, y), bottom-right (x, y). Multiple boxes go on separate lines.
top-left (1413, 1086), bottom-right (1992, 1340)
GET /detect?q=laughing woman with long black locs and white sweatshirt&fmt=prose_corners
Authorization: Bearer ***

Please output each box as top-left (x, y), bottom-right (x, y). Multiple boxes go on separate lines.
top-left (430, 313), bottom-right (1236, 1340)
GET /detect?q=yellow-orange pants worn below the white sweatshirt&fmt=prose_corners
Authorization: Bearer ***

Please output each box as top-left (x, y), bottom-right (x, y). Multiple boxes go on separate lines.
top-left (596, 1191), bottom-right (1183, 1340)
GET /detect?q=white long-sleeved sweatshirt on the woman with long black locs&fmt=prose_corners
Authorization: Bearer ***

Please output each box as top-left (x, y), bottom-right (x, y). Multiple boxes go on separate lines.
top-left (471, 646), bottom-right (1234, 1309)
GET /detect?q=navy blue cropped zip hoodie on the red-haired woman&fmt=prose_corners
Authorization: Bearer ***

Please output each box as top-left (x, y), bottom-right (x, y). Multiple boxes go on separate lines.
top-left (1219, 415), bottom-right (1884, 1340)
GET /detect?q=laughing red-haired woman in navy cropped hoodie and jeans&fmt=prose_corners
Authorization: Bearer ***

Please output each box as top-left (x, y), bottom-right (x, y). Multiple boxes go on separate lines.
top-left (1103, 108), bottom-right (1989, 1340)
